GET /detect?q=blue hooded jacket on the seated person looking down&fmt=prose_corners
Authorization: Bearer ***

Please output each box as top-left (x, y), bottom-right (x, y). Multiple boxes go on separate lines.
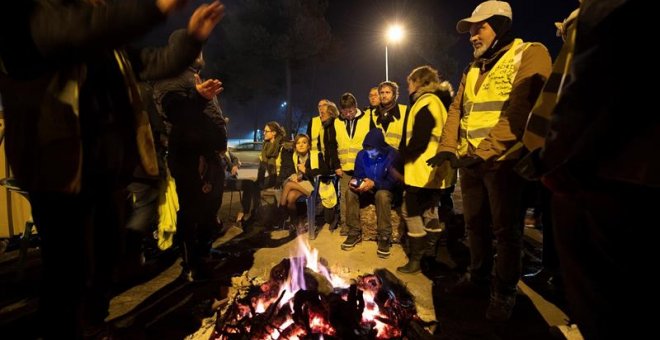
top-left (353, 128), bottom-right (403, 191)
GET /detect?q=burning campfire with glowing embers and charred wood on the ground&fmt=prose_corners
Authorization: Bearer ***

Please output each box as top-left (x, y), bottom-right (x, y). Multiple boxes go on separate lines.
top-left (211, 238), bottom-right (438, 339)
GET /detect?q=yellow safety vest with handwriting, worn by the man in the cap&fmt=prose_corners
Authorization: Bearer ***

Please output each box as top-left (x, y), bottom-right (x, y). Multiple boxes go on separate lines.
top-left (458, 39), bottom-right (532, 160)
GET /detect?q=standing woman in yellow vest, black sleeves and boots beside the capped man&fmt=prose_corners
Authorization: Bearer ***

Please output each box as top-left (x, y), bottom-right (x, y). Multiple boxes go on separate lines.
top-left (397, 66), bottom-right (455, 273)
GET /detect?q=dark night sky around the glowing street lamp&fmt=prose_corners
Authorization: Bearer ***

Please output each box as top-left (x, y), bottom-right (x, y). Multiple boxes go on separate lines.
top-left (143, 0), bottom-right (578, 138)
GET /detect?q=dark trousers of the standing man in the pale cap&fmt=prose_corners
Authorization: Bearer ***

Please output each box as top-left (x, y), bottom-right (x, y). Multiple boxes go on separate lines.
top-left (461, 161), bottom-right (524, 296)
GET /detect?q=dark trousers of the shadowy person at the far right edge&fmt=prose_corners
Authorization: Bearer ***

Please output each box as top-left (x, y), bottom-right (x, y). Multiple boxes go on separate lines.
top-left (552, 182), bottom-right (660, 339)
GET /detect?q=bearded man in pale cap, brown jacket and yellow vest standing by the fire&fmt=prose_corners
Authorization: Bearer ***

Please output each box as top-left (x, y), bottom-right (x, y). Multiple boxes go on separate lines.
top-left (428, 1), bottom-right (552, 321)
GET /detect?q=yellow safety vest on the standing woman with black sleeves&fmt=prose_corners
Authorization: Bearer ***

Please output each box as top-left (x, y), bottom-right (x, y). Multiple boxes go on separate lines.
top-left (403, 93), bottom-right (456, 189)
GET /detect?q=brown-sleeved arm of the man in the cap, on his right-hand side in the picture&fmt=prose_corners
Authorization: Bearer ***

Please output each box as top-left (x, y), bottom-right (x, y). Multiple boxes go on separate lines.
top-left (475, 43), bottom-right (552, 160)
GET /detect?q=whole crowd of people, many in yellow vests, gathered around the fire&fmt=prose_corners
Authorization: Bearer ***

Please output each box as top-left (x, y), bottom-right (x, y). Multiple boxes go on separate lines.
top-left (0, 0), bottom-right (648, 339)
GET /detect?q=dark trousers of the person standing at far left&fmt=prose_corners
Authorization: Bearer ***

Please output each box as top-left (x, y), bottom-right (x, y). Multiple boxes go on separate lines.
top-left (30, 182), bottom-right (125, 339)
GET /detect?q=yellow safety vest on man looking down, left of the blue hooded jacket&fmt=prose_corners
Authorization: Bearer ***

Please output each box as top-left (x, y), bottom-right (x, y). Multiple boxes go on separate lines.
top-left (335, 110), bottom-right (371, 171)
